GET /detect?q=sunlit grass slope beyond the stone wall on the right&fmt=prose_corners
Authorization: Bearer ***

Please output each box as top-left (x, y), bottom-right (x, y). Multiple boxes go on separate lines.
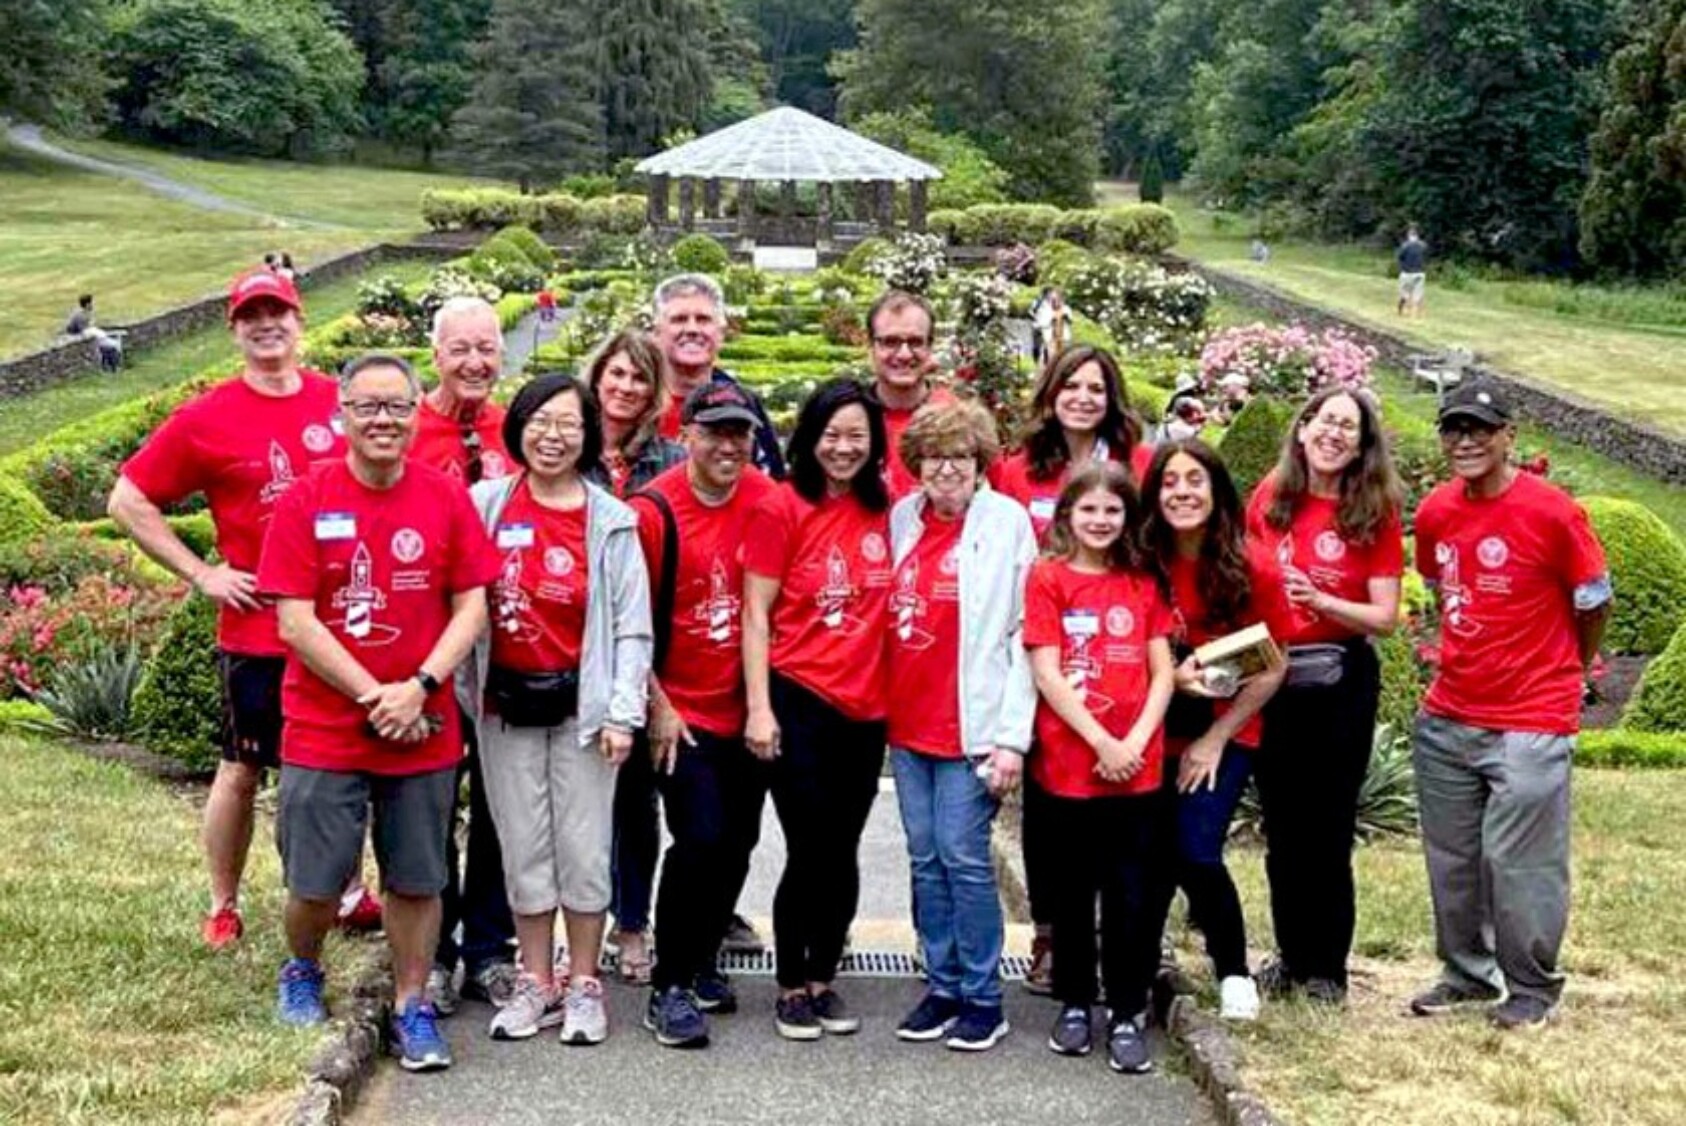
top-left (1101, 184), bottom-right (1686, 433)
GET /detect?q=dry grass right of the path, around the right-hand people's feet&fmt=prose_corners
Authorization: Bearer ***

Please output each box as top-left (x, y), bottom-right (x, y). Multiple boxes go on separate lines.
top-left (1182, 770), bottom-right (1686, 1126)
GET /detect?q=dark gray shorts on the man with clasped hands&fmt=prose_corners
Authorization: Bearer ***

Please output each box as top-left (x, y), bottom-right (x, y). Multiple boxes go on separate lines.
top-left (275, 764), bottom-right (457, 900)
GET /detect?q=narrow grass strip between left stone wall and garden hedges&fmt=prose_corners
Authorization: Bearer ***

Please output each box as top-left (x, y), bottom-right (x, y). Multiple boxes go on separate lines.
top-left (0, 261), bottom-right (428, 455)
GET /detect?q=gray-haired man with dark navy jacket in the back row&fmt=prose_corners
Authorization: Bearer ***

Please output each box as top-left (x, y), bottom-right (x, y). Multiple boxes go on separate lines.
top-left (651, 273), bottom-right (784, 479)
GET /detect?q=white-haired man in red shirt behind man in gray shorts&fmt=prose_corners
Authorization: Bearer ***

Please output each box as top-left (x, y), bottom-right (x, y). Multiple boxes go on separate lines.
top-left (410, 289), bottom-right (519, 1016)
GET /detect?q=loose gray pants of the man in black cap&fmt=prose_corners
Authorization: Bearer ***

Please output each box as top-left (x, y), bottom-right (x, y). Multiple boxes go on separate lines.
top-left (1413, 713), bottom-right (1575, 1005)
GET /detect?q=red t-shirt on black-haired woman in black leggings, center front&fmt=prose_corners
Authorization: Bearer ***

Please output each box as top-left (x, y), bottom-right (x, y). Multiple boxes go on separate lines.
top-left (744, 484), bottom-right (890, 720)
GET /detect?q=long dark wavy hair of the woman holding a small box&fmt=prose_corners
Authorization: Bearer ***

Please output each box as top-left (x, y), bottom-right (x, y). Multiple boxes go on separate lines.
top-left (1141, 438), bottom-right (1253, 630)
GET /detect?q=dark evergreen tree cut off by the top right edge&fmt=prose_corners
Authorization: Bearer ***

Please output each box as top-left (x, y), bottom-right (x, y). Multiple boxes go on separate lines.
top-left (1580, 0), bottom-right (1686, 276)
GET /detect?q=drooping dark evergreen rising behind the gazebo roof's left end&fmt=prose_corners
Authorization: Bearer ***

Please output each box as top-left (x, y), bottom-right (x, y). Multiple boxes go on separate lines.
top-left (596, 0), bottom-right (713, 160)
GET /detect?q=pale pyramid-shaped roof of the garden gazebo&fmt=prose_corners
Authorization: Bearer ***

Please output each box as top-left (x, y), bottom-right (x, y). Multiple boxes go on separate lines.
top-left (637, 106), bottom-right (942, 182)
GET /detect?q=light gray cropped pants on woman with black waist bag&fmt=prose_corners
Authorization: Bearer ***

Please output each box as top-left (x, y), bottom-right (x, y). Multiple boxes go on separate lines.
top-left (481, 716), bottom-right (619, 915)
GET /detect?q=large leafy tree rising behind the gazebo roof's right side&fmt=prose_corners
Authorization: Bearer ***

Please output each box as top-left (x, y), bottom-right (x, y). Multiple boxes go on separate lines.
top-left (835, 0), bottom-right (1106, 206)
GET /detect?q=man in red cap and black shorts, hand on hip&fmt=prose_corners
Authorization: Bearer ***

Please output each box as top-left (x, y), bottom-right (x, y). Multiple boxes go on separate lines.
top-left (106, 270), bottom-right (346, 949)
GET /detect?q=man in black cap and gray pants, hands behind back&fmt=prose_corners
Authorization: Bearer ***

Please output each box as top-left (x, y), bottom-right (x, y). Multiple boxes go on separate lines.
top-left (1411, 383), bottom-right (1612, 1028)
